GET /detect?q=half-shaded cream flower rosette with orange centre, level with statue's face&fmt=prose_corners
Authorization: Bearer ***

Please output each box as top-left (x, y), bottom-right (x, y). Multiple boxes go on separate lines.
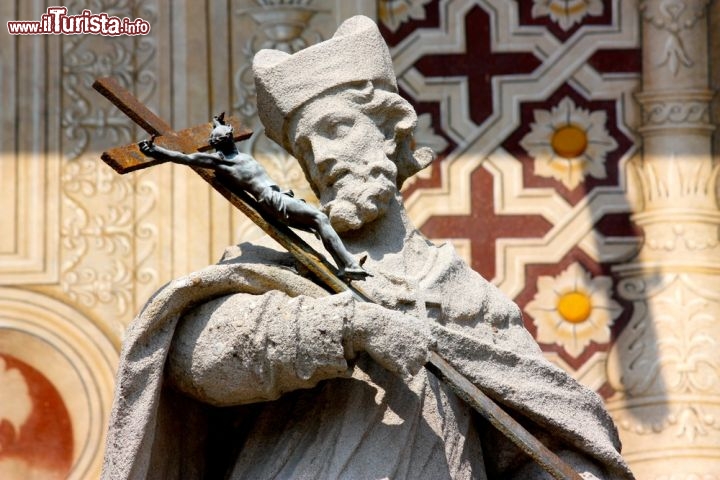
top-left (520, 97), bottom-right (618, 190)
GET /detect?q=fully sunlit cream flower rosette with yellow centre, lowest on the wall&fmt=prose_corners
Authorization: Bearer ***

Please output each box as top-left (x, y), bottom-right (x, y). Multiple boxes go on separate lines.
top-left (525, 262), bottom-right (622, 358)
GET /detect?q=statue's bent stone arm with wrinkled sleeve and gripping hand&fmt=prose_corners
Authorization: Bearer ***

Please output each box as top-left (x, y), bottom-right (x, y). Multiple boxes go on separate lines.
top-left (168, 291), bottom-right (431, 406)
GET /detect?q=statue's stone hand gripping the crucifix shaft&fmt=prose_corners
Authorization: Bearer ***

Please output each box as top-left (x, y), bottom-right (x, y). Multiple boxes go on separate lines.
top-left (351, 303), bottom-right (435, 378)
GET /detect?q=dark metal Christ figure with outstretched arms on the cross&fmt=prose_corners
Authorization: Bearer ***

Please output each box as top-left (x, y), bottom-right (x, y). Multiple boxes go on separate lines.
top-left (139, 112), bottom-right (368, 280)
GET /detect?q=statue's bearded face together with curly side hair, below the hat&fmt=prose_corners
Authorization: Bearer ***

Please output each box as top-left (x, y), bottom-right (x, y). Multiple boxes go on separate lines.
top-left (290, 82), bottom-right (417, 232)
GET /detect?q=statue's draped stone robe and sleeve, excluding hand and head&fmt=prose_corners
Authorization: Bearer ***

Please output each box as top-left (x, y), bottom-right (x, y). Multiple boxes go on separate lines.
top-left (103, 240), bottom-right (632, 480)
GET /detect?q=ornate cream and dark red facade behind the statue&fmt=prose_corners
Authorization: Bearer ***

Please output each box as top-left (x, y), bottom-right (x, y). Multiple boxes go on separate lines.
top-left (0, 0), bottom-right (720, 480)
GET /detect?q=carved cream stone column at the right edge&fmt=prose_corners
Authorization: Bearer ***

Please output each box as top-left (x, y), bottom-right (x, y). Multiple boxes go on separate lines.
top-left (608, 0), bottom-right (720, 480)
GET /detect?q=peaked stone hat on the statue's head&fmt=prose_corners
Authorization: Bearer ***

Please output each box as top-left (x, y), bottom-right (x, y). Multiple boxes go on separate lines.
top-left (253, 15), bottom-right (397, 152)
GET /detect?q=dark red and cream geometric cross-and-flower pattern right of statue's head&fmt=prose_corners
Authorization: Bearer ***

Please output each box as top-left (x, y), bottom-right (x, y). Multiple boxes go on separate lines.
top-left (379, 0), bottom-right (640, 394)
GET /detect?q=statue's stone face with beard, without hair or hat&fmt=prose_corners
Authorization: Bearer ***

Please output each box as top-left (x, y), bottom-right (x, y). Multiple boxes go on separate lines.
top-left (293, 96), bottom-right (397, 232)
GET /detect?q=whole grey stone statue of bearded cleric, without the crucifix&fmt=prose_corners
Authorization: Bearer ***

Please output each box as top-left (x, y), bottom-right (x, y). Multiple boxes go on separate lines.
top-left (103, 17), bottom-right (633, 479)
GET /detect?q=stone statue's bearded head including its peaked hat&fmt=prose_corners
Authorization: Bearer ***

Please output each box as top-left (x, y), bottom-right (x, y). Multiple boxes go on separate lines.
top-left (253, 16), bottom-right (433, 231)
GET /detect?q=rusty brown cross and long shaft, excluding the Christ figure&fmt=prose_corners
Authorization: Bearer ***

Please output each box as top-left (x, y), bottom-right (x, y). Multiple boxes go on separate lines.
top-left (93, 78), bottom-right (582, 480)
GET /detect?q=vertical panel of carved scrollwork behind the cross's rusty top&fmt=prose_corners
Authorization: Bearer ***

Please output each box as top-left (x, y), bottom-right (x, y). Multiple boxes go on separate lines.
top-left (60, 1), bottom-right (160, 337)
